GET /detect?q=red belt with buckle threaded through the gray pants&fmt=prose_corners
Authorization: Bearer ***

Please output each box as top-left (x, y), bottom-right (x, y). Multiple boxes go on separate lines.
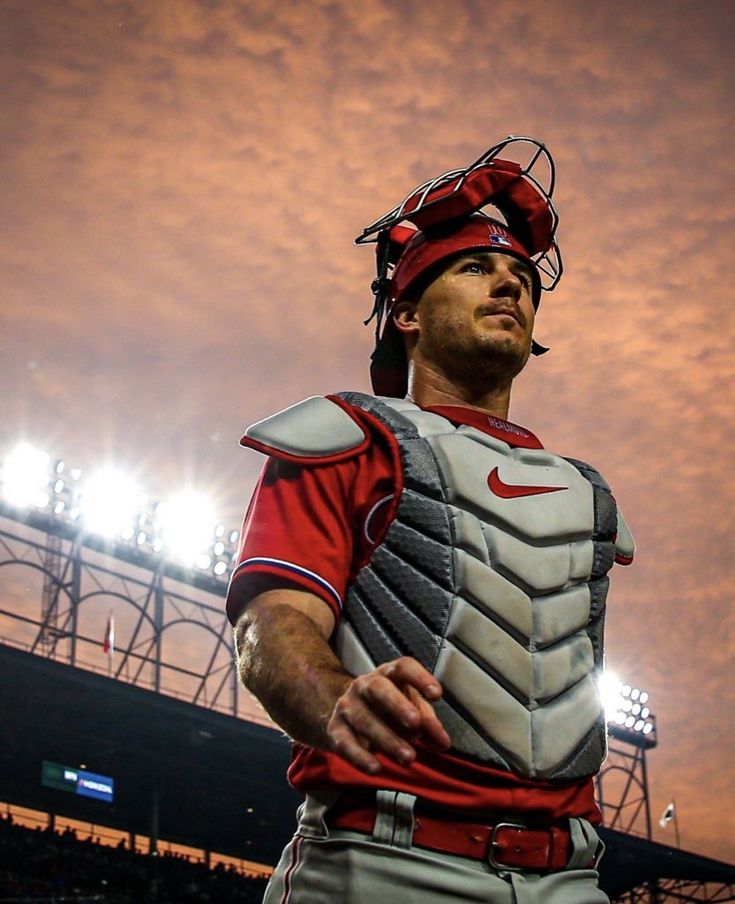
top-left (326, 796), bottom-right (594, 872)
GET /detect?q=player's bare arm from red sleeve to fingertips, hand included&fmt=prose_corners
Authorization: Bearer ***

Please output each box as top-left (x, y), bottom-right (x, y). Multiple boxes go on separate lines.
top-left (235, 588), bottom-right (451, 774)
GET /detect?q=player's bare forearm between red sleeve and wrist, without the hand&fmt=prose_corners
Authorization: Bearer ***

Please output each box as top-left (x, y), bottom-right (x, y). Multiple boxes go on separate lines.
top-left (235, 600), bottom-right (352, 749)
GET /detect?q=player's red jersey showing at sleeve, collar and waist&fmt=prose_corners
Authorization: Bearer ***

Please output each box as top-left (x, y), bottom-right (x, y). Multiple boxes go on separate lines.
top-left (227, 406), bottom-right (600, 824)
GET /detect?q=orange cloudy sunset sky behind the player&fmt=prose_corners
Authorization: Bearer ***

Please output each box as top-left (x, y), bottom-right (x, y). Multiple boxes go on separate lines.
top-left (0, 0), bottom-right (735, 861)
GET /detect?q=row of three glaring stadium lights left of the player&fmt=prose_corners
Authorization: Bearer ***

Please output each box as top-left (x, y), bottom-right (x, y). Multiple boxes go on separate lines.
top-left (0, 443), bottom-right (239, 579)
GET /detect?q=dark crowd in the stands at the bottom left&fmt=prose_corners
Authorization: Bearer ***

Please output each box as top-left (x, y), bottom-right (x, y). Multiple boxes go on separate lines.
top-left (0, 814), bottom-right (266, 904)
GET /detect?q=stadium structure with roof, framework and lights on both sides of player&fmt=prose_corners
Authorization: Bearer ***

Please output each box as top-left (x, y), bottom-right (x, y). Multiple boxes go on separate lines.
top-left (0, 448), bottom-right (735, 904)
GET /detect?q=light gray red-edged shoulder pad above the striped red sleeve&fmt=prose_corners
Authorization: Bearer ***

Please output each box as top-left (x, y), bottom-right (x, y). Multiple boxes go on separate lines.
top-left (240, 396), bottom-right (368, 461)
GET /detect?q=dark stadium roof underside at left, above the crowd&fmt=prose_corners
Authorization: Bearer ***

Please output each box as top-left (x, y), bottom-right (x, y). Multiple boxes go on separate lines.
top-left (0, 645), bottom-right (300, 864)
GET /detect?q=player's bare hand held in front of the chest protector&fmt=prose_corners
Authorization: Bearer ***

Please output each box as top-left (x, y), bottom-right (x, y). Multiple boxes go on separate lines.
top-left (327, 656), bottom-right (451, 774)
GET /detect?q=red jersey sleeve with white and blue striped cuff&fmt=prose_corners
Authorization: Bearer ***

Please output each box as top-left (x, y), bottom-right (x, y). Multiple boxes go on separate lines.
top-left (227, 444), bottom-right (393, 624)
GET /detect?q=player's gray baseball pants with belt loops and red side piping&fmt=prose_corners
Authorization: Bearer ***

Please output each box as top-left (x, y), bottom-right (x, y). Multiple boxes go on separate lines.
top-left (263, 791), bottom-right (609, 904)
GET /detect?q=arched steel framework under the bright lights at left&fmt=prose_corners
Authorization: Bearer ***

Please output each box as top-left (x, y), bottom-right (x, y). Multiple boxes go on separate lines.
top-left (0, 502), bottom-right (269, 724)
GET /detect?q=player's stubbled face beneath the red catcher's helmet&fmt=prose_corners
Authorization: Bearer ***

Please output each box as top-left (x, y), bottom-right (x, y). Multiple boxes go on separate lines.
top-left (414, 251), bottom-right (535, 382)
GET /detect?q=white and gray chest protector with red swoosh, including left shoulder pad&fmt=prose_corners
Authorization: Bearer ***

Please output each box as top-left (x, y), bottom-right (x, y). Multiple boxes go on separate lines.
top-left (246, 393), bottom-right (633, 780)
